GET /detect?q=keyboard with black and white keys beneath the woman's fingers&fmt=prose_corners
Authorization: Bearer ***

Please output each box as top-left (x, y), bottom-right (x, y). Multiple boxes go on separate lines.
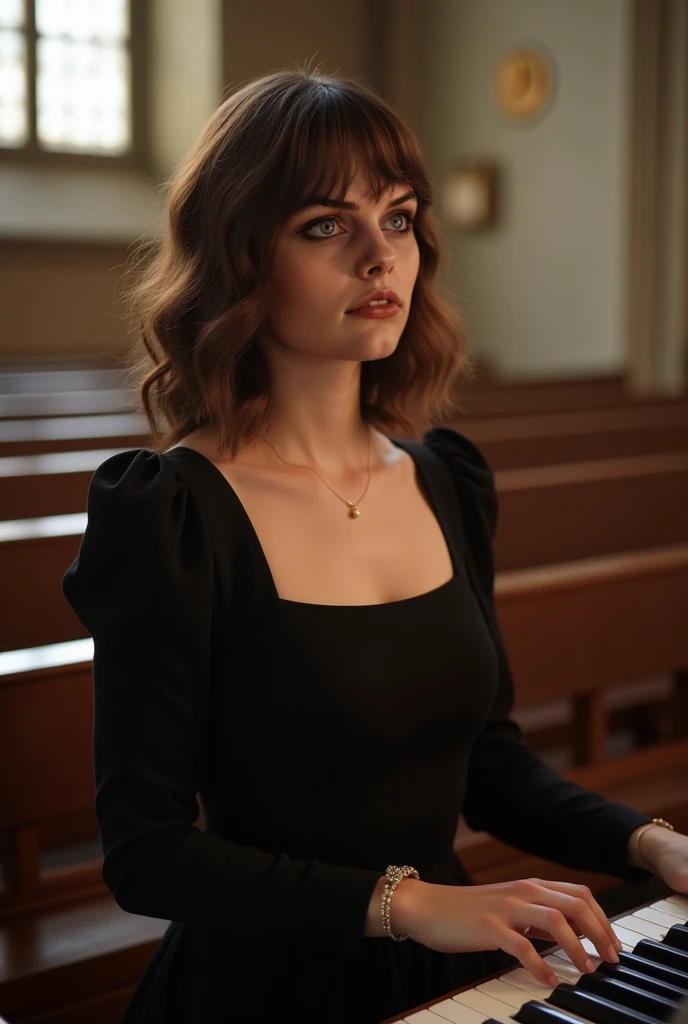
top-left (382, 894), bottom-right (688, 1024)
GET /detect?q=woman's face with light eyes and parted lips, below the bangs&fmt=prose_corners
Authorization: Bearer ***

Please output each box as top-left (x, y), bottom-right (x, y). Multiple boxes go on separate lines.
top-left (265, 175), bottom-right (420, 360)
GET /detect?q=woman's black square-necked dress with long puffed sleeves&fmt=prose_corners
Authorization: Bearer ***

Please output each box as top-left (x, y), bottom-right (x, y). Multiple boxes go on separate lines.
top-left (62, 427), bottom-right (651, 1024)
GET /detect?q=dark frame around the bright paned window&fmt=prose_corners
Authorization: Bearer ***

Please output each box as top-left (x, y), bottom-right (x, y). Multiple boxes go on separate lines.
top-left (0, 0), bottom-right (152, 173)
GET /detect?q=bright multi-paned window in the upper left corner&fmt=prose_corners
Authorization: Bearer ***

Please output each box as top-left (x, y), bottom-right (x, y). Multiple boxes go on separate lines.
top-left (0, 0), bottom-right (143, 167)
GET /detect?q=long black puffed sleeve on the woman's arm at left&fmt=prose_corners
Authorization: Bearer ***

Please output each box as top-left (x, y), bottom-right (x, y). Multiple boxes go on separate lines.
top-left (62, 449), bottom-right (380, 952)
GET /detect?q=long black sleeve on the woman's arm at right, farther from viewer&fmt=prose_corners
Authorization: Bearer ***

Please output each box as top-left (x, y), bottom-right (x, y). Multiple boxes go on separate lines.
top-left (424, 427), bottom-right (652, 882)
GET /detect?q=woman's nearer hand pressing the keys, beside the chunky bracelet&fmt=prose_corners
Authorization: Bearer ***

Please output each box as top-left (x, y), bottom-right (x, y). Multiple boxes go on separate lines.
top-left (390, 879), bottom-right (621, 985)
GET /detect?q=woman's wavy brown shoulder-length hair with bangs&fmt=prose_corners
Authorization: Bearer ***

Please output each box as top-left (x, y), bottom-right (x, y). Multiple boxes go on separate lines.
top-left (124, 61), bottom-right (476, 458)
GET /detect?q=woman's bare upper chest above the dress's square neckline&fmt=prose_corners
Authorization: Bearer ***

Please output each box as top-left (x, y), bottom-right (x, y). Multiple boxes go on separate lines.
top-left (211, 452), bottom-right (454, 604)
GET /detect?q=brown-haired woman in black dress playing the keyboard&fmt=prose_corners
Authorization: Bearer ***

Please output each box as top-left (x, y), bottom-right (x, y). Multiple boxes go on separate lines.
top-left (63, 70), bottom-right (685, 1024)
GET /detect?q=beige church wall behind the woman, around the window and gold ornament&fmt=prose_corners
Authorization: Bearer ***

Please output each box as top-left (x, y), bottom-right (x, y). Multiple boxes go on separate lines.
top-left (0, 0), bottom-right (685, 385)
